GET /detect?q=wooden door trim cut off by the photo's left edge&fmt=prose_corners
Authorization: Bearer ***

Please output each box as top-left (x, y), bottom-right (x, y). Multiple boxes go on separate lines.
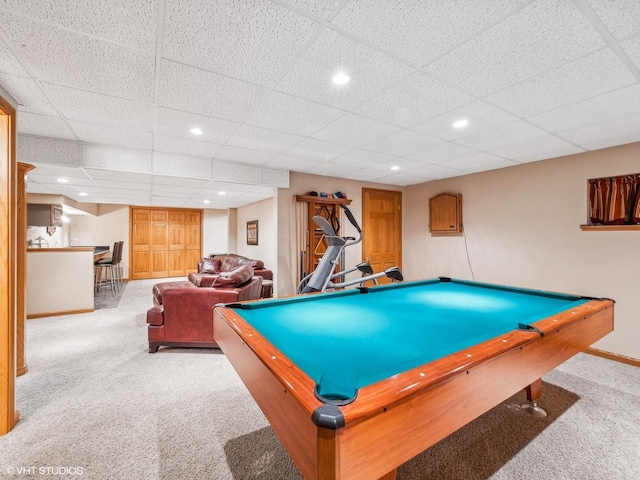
top-left (0, 97), bottom-right (19, 435)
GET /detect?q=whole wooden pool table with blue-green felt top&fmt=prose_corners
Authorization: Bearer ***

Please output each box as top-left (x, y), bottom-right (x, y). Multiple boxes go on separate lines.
top-left (213, 277), bottom-right (613, 479)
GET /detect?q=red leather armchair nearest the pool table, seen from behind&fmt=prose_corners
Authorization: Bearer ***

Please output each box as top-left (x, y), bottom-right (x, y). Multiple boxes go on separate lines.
top-left (147, 276), bottom-right (262, 353)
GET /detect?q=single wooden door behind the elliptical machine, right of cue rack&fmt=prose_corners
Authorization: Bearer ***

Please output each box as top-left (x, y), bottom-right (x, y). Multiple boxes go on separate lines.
top-left (362, 188), bottom-right (402, 283)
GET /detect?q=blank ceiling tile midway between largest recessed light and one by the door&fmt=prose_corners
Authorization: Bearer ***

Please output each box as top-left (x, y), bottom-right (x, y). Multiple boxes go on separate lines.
top-left (313, 113), bottom-right (400, 148)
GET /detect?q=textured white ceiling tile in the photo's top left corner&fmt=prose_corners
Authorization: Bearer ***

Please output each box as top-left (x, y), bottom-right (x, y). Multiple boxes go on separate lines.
top-left (2, 0), bottom-right (158, 52)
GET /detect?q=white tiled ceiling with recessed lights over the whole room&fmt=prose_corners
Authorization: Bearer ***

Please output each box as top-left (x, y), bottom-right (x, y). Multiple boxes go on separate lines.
top-left (0, 0), bottom-right (640, 208)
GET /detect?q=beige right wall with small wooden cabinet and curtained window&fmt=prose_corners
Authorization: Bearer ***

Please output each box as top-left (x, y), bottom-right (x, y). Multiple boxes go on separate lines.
top-left (403, 143), bottom-right (640, 359)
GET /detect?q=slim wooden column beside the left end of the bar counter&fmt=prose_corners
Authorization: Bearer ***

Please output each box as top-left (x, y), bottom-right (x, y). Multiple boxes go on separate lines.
top-left (16, 163), bottom-right (35, 376)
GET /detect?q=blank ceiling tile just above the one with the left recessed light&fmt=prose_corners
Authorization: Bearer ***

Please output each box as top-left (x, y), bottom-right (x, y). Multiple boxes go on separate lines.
top-left (160, 60), bottom-right (267, 122)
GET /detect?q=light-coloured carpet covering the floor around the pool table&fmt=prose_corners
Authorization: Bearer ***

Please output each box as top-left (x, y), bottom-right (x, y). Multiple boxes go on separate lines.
top-left (0, 279), bottom-right (640, 480)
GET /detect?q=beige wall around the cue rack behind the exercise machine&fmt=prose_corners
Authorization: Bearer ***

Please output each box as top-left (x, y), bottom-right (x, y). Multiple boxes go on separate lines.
top-left (276, 172), bottom-right (404, 296)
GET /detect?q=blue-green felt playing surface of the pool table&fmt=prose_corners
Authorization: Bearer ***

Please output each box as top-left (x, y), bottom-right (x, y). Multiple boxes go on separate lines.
top-left (230, 279), bottom-right (588, 400)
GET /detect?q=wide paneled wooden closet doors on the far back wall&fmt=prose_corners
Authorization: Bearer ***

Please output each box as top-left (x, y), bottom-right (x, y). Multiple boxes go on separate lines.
top-left (130, 207), bottom-right (202, 279)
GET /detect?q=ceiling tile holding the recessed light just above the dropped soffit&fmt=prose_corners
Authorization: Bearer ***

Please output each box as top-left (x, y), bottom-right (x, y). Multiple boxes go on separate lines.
top-left (156, 107), bottom-right (242, 144)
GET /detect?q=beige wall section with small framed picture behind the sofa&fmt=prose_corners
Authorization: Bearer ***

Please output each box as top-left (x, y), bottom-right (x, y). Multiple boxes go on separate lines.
top-left (234, 197), bottom-right (278, 280)
